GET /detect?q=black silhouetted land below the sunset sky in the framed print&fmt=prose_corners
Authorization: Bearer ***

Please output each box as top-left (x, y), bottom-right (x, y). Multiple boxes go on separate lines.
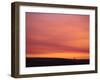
top-left (26, 58), bottom-right (89, 67)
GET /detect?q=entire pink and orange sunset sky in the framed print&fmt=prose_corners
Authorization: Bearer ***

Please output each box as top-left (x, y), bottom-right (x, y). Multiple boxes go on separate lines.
top-left (26, 12), bottom-right (89, 59)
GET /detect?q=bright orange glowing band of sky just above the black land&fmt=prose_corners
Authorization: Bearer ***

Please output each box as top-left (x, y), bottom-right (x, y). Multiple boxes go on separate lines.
top-left (26, 52), bottom-right (89, 59)
